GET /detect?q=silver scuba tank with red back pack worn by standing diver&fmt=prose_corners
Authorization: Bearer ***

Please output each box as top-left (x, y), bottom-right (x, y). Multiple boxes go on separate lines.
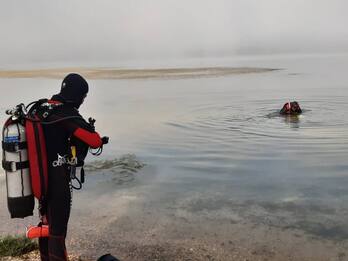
top-left (2, 99), bottom-right (48, 218)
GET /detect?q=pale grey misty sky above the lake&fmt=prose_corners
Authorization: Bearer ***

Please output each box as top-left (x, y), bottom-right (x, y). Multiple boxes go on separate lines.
top-left (0, 0), bottom-right (348, 66)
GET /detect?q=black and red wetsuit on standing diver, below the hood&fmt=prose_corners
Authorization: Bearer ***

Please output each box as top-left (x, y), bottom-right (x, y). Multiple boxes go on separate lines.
top-left (39, 95), bottom-right (102, 261)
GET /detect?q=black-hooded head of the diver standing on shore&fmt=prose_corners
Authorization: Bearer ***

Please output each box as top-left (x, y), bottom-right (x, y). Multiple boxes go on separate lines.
top-left (58, 73), bottom-right (88, 109)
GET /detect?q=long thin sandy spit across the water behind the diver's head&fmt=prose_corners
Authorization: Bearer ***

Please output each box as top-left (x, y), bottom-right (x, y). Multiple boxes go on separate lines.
top-left (0, 67), bottom-right (277, 79)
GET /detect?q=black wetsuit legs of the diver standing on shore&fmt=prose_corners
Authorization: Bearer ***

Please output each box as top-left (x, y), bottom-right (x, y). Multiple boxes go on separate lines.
top-left (48, 167), bottom-right (71, 261)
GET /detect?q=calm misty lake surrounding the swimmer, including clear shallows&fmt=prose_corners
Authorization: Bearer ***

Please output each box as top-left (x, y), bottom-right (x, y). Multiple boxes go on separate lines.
top-left (0, 54), bottom-right (348, 260)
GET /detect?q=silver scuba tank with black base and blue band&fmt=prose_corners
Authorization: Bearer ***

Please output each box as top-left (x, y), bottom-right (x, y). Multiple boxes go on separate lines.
top-left (2, 118), bottom-right (34, 218)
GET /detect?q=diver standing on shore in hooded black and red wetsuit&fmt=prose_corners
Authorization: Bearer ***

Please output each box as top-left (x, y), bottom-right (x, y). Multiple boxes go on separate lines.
top-left (39, 74), bottom-right (108, 261)
